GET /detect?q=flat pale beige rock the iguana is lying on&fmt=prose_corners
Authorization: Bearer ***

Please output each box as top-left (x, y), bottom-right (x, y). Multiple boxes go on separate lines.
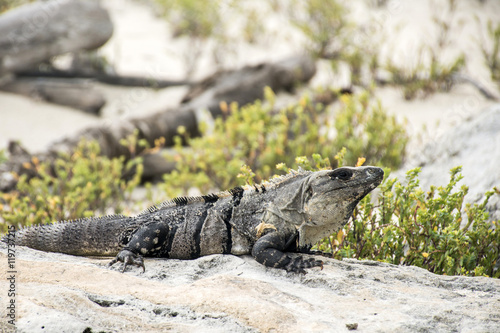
top-left (0, 243), bottom-right (500, 332)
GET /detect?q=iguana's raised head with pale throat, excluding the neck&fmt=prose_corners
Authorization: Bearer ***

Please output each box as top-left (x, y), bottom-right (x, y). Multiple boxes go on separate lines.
top-left (299, 166), bottom-right (384, 246)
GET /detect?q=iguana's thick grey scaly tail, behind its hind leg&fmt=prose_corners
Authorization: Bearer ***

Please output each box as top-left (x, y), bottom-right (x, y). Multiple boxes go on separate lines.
top-left (2, 215), bottom-right (136, 256)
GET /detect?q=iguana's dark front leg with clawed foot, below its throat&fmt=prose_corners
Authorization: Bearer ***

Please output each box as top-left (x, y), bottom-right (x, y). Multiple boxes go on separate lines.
top-left (252, 231), bottom-right (323, 274)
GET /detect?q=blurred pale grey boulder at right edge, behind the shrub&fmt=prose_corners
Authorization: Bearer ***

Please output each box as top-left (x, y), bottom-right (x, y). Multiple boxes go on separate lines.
top-left (393, 104), bottom-right (500, 220)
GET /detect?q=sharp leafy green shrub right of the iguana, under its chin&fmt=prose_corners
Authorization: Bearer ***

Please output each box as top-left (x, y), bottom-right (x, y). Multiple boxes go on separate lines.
top-left (317, 167), bottom-right (500, 277)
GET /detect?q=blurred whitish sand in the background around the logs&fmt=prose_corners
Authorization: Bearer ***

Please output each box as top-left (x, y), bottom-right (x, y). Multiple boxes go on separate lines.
top-left (0, 0), bottom-right (500, 152)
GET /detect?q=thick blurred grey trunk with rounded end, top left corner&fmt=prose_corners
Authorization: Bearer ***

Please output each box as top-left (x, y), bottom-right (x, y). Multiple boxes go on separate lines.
top-left (0, 0), bottom-right (113, 76)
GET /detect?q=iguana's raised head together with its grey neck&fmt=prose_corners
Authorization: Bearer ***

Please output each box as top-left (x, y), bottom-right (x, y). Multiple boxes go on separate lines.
top-left (266, 166), bottom-right (384, 247)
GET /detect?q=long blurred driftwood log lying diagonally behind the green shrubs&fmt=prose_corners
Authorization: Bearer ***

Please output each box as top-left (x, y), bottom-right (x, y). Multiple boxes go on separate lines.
top-left (0, 56), bottom-right (316, 191)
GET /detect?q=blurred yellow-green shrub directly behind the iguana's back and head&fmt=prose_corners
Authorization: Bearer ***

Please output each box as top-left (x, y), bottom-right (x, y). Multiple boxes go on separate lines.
top-left (163, 89), bottom-right (408, 196)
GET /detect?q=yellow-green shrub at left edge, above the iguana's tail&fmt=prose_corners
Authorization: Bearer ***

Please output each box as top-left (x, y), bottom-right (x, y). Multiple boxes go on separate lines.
top-left (0, 141), bottom-right (142, 233)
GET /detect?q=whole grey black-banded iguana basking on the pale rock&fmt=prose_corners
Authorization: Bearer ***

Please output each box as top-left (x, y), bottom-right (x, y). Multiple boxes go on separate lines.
top-left (4, 167), bottom-right (384, 273)
